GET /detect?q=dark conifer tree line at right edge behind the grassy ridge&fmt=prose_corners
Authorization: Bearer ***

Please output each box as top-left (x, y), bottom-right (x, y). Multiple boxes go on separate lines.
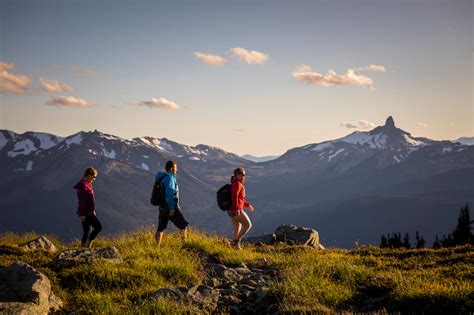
top-left (380, 204), bottom-right (474, 249)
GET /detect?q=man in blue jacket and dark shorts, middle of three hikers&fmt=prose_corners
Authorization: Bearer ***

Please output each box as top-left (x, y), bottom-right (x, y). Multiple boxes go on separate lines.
top-left (155, 161), bottom-right (189, 246)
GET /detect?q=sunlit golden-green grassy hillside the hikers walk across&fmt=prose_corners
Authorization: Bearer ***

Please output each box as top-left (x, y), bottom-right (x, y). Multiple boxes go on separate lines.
top-left (0, 230), bottom-right (474, 313)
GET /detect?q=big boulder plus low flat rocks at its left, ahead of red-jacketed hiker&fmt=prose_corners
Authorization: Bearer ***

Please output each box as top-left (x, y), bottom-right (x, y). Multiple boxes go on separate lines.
top-left (244, 224), bottom-right (324, 249)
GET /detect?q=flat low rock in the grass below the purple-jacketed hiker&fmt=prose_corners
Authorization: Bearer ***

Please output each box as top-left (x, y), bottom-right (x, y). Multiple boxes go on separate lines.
top-left (57, 246), bottom-right (122, 268)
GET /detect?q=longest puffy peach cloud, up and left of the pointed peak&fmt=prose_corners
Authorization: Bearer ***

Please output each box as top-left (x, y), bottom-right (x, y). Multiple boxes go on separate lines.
top-left (292, 65), bottom-right (374, 87)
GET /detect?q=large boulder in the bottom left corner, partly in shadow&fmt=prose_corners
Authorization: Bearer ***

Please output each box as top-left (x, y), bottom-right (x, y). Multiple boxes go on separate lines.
top-left (0, 262), bottom-right (63, 314)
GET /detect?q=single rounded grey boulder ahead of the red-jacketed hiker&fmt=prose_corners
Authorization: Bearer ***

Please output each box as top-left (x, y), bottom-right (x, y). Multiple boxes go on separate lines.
top-left (275, 224), bottom-right (319, 248)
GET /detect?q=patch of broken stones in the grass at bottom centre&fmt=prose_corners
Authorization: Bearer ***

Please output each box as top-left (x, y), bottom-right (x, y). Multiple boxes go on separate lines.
top-left (151, 263), bottom-right (280, 314)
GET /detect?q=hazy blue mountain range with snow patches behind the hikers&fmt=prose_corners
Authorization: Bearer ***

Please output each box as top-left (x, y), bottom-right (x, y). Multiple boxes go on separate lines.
top-left (0, 117), bottom-right (474, 247)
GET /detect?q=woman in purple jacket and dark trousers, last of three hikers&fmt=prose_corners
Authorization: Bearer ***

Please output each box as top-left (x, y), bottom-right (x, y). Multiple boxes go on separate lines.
top-left (74, 167), bottom-right (102, 247)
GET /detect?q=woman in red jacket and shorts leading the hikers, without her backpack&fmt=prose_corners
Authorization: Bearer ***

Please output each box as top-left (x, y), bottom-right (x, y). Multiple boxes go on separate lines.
top-left (227, 167), bottom-right (253, 249)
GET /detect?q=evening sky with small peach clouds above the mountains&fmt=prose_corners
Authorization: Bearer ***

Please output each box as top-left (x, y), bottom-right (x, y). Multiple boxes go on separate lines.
top-left (0, 0), bottom-right (474, 156)
